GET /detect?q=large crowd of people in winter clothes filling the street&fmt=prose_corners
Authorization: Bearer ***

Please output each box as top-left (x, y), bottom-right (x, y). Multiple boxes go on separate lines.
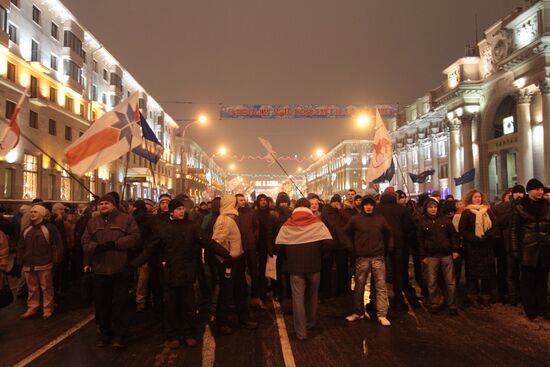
top-left (0, 179), bottom-right (550, 349)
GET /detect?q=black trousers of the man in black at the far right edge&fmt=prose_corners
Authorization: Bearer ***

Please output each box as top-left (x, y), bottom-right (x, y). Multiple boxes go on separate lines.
top-left (521, 264), bottom-right (548, 319)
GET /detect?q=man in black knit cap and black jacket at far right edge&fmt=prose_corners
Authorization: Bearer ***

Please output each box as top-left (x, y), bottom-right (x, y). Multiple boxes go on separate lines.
top-left (511, 178), bottom-right (550, 320)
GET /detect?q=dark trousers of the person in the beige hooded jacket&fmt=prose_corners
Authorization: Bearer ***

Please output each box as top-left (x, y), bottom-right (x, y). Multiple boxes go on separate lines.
top-left (216, 256), bottom-right (250, 326)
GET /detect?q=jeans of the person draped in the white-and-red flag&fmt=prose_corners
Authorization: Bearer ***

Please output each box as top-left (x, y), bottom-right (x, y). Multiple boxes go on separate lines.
top-left (290, 273), bottom-right (320, 339)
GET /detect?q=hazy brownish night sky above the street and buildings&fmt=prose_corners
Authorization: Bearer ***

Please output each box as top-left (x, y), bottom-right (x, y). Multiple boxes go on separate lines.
top-left (63, 0), bottom-right (521, 173)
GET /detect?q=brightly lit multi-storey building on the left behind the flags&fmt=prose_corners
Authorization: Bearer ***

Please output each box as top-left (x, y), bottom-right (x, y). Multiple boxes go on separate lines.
top-left (0, 0), bottom-right (222, 201)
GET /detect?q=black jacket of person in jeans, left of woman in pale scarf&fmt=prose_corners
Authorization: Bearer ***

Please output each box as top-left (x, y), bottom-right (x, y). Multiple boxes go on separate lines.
top-left (417, 214), bottom-right (459, 257)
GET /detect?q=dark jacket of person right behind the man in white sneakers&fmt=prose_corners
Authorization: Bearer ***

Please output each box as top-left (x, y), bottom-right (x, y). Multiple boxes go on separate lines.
top-left (375, 193), bottom-right (415, 252)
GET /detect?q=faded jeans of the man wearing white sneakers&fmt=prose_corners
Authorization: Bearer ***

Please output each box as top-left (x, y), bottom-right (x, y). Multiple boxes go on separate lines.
top-left (354, 256), bottom-right (388, 317)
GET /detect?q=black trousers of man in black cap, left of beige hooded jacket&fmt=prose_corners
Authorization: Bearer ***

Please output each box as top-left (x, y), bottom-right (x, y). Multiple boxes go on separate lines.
top-left (164, 284), bottom-right (197, 340)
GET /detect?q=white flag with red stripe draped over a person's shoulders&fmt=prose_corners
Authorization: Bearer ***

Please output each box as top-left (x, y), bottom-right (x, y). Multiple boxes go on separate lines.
top-left (275, 207), bottom-right (332, 245)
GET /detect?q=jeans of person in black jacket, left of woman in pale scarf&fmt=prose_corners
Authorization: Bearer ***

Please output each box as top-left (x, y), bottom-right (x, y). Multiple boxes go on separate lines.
top-left (422, 255), bottom-right (456, 307)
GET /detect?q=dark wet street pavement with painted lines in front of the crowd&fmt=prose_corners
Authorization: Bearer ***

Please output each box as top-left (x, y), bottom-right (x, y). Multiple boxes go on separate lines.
top-left (0, 280), bottom-right (550, 367)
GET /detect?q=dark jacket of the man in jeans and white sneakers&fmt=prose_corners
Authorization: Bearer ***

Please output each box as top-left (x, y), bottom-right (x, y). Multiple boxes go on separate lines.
top-left (344, 212), bottom-right (394, 257)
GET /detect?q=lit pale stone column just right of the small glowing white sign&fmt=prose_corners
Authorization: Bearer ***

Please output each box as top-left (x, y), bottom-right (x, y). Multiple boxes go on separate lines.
top-left (516, 89), bottom-right (545, 185)
